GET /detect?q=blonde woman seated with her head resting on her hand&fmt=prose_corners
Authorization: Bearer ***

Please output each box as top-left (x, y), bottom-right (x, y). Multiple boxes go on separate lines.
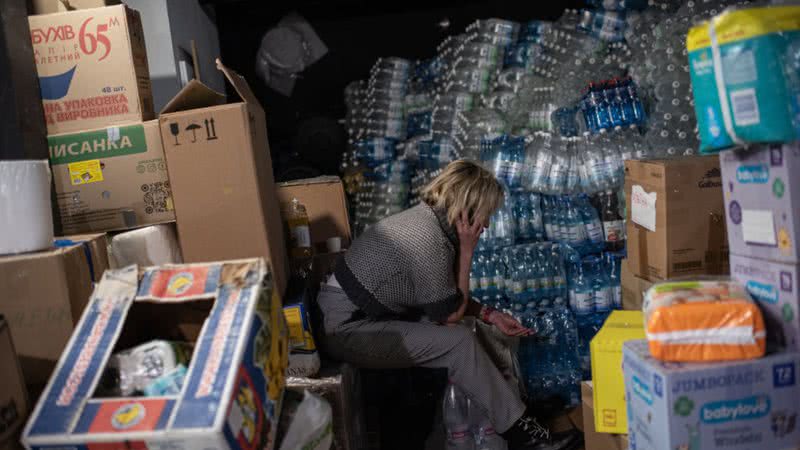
top-left (318, 160), bottom-right (576, 450)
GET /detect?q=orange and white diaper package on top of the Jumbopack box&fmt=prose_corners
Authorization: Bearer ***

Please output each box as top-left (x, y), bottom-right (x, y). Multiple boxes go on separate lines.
top-left (644, 280), bottom-right (766, 362)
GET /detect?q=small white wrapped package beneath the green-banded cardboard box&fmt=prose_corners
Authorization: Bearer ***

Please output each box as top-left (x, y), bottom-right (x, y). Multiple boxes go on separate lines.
top-left (111, 224), bottom-right (183, 267)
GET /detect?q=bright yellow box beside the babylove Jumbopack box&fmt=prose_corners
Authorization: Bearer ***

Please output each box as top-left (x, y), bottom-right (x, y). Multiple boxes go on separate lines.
top-left (589, 311), bottom-right (645, 434)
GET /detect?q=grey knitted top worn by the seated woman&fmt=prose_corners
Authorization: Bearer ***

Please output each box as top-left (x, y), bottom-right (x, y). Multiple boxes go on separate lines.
top-left (335, 202), bottom-right (463, 322)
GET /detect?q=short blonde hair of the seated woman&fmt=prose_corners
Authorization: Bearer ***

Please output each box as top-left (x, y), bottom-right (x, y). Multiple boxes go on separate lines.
top-left (422, 159), bottom-right (505, 225)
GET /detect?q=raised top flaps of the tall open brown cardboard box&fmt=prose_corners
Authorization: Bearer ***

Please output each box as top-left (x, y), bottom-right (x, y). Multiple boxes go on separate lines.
top-left (161, 58), bottom-right (260, 114)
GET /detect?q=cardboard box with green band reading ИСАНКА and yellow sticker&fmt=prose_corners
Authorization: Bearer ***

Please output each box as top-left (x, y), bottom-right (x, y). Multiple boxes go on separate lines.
top-left (47, 120), bottom-right (175, 234)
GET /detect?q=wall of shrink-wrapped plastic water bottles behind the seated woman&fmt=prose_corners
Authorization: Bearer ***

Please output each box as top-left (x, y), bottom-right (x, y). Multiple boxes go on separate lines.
top-left (345, 0), bottom-right (764, 416)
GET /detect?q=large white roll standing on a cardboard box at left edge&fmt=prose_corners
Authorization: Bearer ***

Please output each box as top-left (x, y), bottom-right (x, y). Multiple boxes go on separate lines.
top-left (0, 160), bottom-right (53, 255)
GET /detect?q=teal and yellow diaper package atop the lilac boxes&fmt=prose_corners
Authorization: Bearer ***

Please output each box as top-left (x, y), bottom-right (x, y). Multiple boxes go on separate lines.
top-left (686, 6), bottom-right (800, 154)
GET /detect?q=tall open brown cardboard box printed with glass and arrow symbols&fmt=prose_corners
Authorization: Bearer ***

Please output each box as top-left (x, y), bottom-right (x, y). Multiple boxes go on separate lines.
top-left (159, 62), bottom-right (287, 293)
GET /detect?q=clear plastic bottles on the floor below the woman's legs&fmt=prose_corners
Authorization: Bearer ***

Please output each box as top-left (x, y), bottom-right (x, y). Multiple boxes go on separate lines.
top-left (442, 383), bottom-right (506, 450)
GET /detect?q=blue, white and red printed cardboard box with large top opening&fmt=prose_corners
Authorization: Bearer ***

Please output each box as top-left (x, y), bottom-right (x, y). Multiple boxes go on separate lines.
top-left (22, 259), bottom-right (288, 450)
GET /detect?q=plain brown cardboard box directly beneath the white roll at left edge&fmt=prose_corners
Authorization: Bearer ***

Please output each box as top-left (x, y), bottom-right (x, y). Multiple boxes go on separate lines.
top-left (0, 239), bottom-right (100, 390)
